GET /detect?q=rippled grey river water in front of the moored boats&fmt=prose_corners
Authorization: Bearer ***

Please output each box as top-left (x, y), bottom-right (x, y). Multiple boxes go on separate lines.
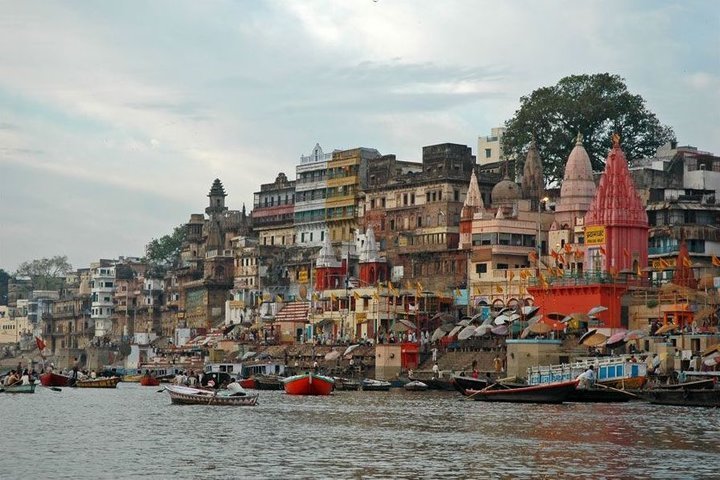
top-left (0, 383), bottom-right (720, 479)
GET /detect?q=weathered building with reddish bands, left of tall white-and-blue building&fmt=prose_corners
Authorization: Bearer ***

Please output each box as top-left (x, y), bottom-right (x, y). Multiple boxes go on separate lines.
top-left (250, 172), bottom-right (295, 245)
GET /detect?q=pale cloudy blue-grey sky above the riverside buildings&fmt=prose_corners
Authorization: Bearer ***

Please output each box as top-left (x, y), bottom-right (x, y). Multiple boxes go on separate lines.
top-left (0, 0), bottom-right (720, 272)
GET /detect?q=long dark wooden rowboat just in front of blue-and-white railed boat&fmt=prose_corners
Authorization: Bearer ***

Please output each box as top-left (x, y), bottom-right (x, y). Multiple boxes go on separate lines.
top-left (466, 380), bottom-right (578, 403)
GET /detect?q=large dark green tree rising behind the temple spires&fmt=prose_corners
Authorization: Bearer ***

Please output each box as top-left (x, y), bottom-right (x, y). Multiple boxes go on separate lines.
top-left (503, 73), bottom-right (675, 182)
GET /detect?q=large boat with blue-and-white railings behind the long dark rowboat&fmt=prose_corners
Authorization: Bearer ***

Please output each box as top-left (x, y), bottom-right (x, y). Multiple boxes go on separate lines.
top-left (527, 356), bottom-right (647, 390)
